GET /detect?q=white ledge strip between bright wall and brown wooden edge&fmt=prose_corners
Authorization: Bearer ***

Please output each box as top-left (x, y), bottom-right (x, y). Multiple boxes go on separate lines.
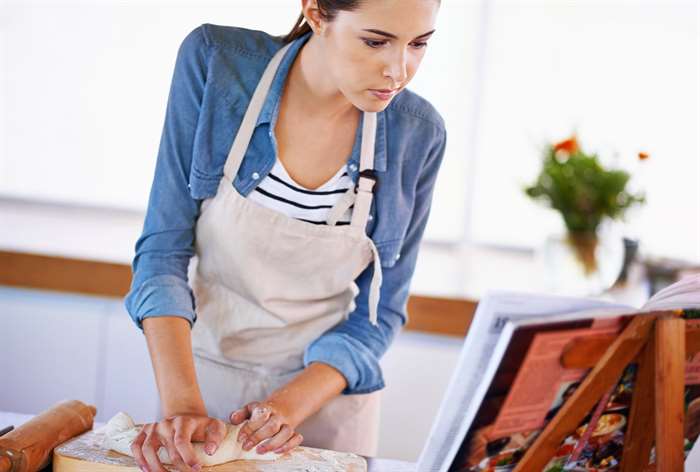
top-left (0, 196), bottom-right (646, 306)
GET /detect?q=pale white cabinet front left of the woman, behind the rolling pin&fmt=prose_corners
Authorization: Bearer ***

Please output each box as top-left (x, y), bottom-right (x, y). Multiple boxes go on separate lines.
top-left (0, 287), bottom-right (159, 422)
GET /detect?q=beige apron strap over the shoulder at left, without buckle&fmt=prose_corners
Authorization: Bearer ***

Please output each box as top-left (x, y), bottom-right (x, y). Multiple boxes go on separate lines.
top-left (224, 42), bottom-right (293, 182)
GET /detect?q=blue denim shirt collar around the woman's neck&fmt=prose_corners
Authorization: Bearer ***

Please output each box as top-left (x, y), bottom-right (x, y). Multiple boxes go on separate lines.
top-left (255, 31), bottom-right (386, 173)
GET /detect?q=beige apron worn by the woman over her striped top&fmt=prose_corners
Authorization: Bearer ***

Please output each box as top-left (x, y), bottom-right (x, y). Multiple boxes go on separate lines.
top-left (188, 44), bottom-right (381, 456)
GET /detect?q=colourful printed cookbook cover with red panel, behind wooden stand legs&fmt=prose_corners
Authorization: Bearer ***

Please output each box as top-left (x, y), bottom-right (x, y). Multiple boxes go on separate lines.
top-left (448, 317), bottom-right (700, 472)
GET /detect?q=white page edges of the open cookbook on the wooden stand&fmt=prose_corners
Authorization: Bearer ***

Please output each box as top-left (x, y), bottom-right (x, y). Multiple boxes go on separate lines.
top-left (418, 274), bottom-right (700, 472)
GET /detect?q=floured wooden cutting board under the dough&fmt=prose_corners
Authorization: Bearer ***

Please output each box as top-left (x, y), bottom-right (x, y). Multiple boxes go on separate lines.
top-left (53, 427), bottom-right (367, 472)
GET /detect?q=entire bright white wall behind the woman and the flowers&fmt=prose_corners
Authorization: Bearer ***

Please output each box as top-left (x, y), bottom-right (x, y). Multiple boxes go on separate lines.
top-left (0, 0), bottom-right (700, 261)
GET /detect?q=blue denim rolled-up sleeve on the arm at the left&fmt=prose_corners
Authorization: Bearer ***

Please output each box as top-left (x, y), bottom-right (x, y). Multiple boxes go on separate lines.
top-left (124, 25), bottom-right (209, 330)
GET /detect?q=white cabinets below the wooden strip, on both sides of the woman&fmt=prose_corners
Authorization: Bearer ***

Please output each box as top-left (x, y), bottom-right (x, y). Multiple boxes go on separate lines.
top-left (0, 286), bottom-right (462, 461)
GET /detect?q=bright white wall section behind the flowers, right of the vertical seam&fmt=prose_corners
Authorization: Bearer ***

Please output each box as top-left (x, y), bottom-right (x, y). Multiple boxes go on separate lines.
top-left (470, 0), bottom-right (700, 262)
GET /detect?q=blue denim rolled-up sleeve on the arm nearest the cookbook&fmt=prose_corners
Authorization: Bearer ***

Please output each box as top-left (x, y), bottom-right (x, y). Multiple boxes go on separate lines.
top-left (304, 124), bottom-right (447, 395)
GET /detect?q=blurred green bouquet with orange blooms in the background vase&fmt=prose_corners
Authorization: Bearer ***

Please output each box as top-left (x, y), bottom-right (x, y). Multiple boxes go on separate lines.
top-left (524, 135), bottom-right (648, 292)
